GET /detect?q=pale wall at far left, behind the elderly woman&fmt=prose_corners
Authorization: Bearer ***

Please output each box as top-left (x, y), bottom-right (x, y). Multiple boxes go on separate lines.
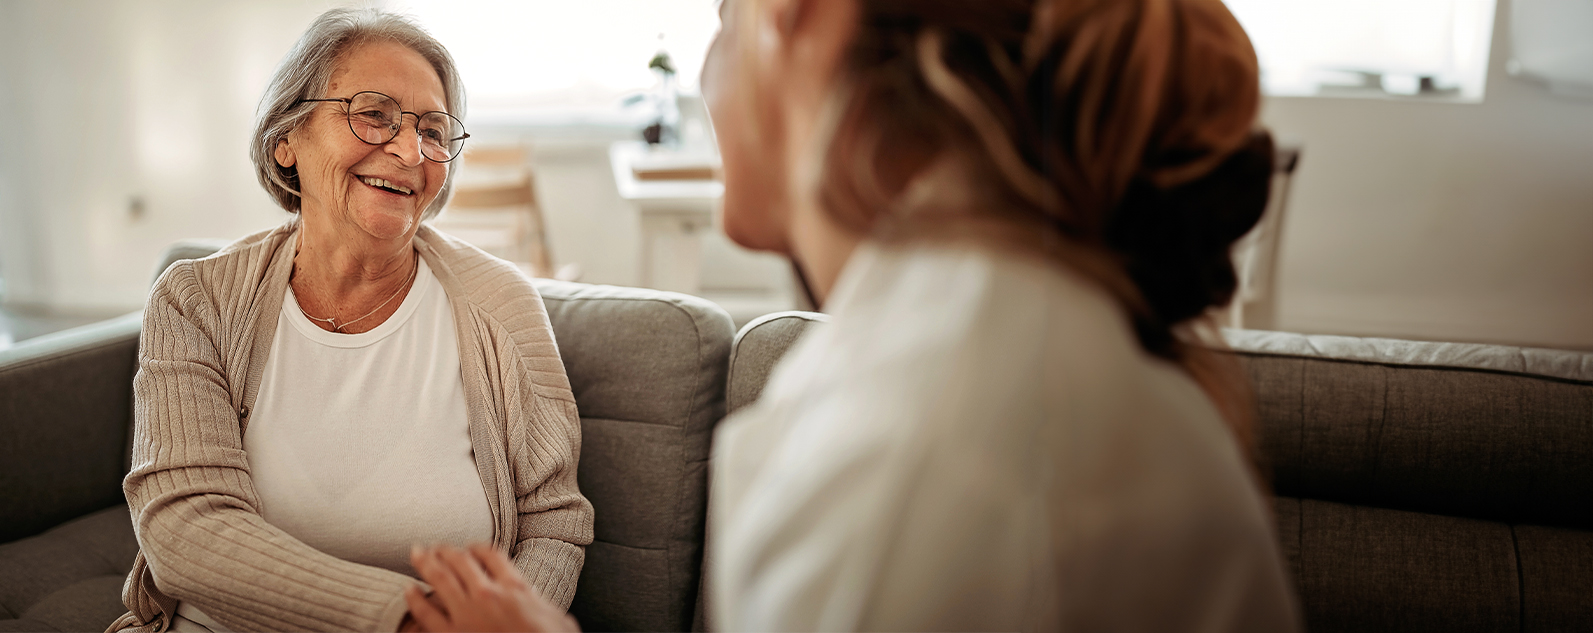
top-left (0, 0), bottom-right (345, 313)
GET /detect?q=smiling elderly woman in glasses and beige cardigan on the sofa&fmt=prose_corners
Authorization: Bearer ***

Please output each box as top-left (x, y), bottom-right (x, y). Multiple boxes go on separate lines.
top-left (112, 10), bottom-right (593, 631)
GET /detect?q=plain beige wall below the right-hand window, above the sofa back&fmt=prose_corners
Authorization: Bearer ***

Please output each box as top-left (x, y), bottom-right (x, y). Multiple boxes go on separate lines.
top-left (1263, 0), bottom-right (1593, 349)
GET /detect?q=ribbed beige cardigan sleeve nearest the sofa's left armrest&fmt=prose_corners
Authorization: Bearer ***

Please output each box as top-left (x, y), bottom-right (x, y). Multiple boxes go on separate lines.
top-left (124, 261), bottom-right (416, 631)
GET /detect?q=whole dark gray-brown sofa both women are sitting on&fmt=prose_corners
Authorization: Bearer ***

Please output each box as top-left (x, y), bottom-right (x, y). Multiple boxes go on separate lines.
top-left (0, 243), bottom-right (1593, 631)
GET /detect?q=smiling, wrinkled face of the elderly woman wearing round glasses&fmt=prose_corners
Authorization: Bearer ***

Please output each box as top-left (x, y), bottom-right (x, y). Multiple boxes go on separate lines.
top-left (276, 41), bottom-right (448, 239)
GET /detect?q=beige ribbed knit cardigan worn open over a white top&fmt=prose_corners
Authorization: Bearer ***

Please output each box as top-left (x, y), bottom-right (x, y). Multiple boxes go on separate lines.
top-left (110, 222), bottom-right (593, 631)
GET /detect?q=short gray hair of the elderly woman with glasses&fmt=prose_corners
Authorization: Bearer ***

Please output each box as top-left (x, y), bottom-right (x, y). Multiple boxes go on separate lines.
top-left (249, 8), bottom-right (465, 220)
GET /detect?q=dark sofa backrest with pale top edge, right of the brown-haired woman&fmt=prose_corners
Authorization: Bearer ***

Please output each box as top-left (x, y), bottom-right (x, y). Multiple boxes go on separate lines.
top-left (1228, 330), bottom-right (1593, 529)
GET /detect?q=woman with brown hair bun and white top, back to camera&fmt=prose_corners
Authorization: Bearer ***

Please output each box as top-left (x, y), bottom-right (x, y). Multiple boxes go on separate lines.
top-left (398, 0), bottom-right (1298, 631)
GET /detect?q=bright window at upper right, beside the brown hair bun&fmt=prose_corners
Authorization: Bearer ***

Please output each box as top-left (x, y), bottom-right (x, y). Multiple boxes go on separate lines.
top-left (1225, 0), bottom-right (1494, 100)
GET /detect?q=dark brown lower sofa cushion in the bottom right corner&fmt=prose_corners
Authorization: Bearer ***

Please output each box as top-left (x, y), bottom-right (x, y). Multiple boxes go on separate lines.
top-left (1274, 497), bottom-right (1593, 633)
